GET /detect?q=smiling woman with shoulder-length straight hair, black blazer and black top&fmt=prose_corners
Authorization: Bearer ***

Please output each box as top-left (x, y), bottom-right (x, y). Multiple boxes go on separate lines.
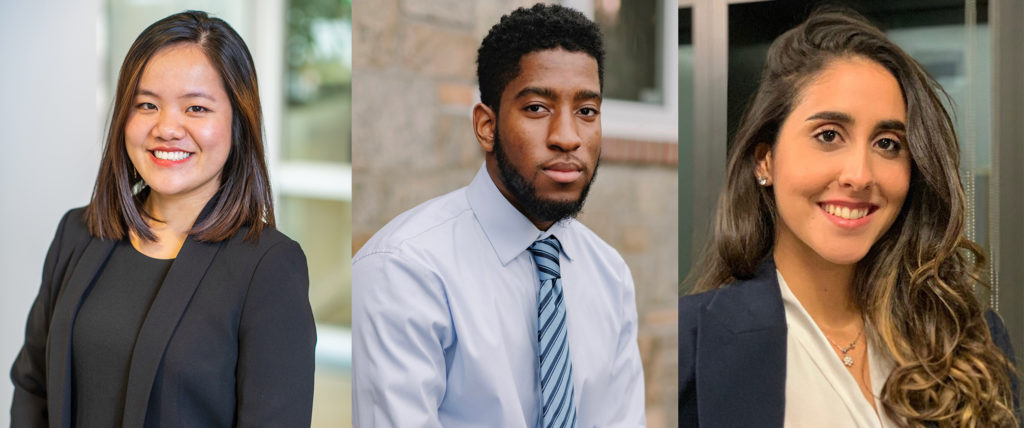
top-left (11, 11), bottom-right (315, 427)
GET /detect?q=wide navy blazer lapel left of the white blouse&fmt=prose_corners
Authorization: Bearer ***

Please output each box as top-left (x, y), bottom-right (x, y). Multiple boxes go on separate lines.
top-left (695, 261), bottom-right (786, 427)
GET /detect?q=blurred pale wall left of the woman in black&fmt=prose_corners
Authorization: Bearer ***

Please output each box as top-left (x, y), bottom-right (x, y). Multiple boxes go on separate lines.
top-left (0, 0), bottom-right (105, 426)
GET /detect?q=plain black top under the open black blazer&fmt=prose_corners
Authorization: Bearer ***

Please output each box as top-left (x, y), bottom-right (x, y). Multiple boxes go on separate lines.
top-left (72, 241), bottom-right (174, 427)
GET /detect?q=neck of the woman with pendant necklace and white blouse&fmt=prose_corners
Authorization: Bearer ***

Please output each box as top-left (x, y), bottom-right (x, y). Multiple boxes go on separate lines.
top-left (773, 233), bottom-right (862, 332)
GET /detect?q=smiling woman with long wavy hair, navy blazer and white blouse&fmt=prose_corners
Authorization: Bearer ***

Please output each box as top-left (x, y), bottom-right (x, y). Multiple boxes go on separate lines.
top-left (679, 10), bottom-right (1019, 427)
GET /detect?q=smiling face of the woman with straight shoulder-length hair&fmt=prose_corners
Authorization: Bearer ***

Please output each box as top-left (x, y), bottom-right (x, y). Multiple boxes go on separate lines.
top-left (125, 43), bottom-right (231, 199)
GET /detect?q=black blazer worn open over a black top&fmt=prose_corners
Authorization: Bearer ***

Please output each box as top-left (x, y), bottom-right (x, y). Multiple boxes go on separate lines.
top-left (11, 206), bottom-right (316, 427)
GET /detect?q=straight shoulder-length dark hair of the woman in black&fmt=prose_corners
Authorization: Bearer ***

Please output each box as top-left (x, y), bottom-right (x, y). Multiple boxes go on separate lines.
top-left (85, 10), bottom-right (274, 242)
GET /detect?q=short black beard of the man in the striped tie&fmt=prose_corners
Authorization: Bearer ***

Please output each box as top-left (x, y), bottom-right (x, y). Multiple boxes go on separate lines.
top-left (495, 129), bottom-right (600, 222)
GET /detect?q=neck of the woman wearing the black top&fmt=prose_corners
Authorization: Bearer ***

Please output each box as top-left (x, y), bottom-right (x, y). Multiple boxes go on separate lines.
top-left (131, 187), bottom-right (213, 259)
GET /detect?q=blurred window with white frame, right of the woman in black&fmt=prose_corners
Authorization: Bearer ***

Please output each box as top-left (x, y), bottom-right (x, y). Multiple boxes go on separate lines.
top-left (274, 0), bottom-right (352, 427)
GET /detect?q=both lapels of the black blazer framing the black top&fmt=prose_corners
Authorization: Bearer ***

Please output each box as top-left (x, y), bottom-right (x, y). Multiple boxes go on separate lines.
top-left (46, 196), bottom-right (222, 427)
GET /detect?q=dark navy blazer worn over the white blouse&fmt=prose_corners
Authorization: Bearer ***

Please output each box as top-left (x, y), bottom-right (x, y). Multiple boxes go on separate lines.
top-left (679, 259), bottom-right (1017, 427)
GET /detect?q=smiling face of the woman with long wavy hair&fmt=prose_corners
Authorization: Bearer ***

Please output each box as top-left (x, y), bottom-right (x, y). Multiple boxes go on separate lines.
top-left (751, 56), bottom-right (910, 265)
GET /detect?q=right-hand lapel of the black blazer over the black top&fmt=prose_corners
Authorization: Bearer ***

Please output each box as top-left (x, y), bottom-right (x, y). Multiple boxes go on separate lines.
top-left (122, 237), bottom-right (222, 427)
